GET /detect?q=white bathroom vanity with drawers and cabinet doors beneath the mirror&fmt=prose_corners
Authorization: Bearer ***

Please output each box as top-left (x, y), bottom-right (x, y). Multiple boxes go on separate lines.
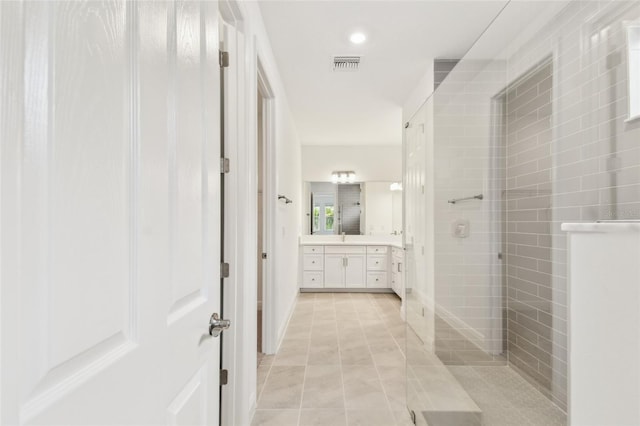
top-left (299, 235), bottom-right (404, 297)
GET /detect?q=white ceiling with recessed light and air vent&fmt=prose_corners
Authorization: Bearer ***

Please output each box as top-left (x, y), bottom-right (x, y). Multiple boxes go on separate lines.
top-left (260, 0), bottom-right (506, 145)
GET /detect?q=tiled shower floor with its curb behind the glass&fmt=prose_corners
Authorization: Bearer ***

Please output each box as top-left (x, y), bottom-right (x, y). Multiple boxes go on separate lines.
top-left (407, 327), bottom-right (567, 426)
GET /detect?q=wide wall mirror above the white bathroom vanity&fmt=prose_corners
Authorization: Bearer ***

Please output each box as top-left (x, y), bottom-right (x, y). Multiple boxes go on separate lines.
top-left (303, 182), bottom-right (402, 235)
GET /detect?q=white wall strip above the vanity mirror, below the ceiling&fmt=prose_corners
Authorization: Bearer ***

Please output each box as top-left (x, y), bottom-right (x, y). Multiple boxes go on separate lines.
top-left (302, 145), bottom-right (402, 182)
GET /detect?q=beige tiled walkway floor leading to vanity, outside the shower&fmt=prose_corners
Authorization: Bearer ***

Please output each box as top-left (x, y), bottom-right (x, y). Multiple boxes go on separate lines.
top-left (252, 293), bottom-right (412, 426)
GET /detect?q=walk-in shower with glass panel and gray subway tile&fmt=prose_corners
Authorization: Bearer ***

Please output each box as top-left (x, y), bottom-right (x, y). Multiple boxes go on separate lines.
top-left (404, 1), bottom-right (640, 426)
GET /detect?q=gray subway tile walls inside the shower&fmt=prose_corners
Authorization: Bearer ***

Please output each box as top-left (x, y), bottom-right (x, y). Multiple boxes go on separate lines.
top-left (431, 1), bottom-right (640, 408)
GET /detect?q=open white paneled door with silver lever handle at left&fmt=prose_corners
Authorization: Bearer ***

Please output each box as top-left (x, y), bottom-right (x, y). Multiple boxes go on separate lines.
top-left (0, 0), bottom-right (220, 425)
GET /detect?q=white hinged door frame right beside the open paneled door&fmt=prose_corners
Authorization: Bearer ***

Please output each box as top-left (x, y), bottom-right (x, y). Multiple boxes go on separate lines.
top-left (218, 0), bottom-right (242, 426)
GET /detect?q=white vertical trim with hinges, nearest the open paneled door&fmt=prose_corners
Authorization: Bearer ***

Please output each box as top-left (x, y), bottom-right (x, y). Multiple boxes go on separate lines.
top-left (218, 0), bottom-right (251, 426)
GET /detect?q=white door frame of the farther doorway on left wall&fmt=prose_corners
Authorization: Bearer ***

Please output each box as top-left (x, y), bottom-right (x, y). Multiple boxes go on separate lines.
top-left (256, 58), bottom-right (278, 354)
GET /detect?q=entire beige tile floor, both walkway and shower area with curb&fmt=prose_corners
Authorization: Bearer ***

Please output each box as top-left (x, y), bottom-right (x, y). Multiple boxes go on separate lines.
top-left (252, 293), bottom-right (566, 426)
